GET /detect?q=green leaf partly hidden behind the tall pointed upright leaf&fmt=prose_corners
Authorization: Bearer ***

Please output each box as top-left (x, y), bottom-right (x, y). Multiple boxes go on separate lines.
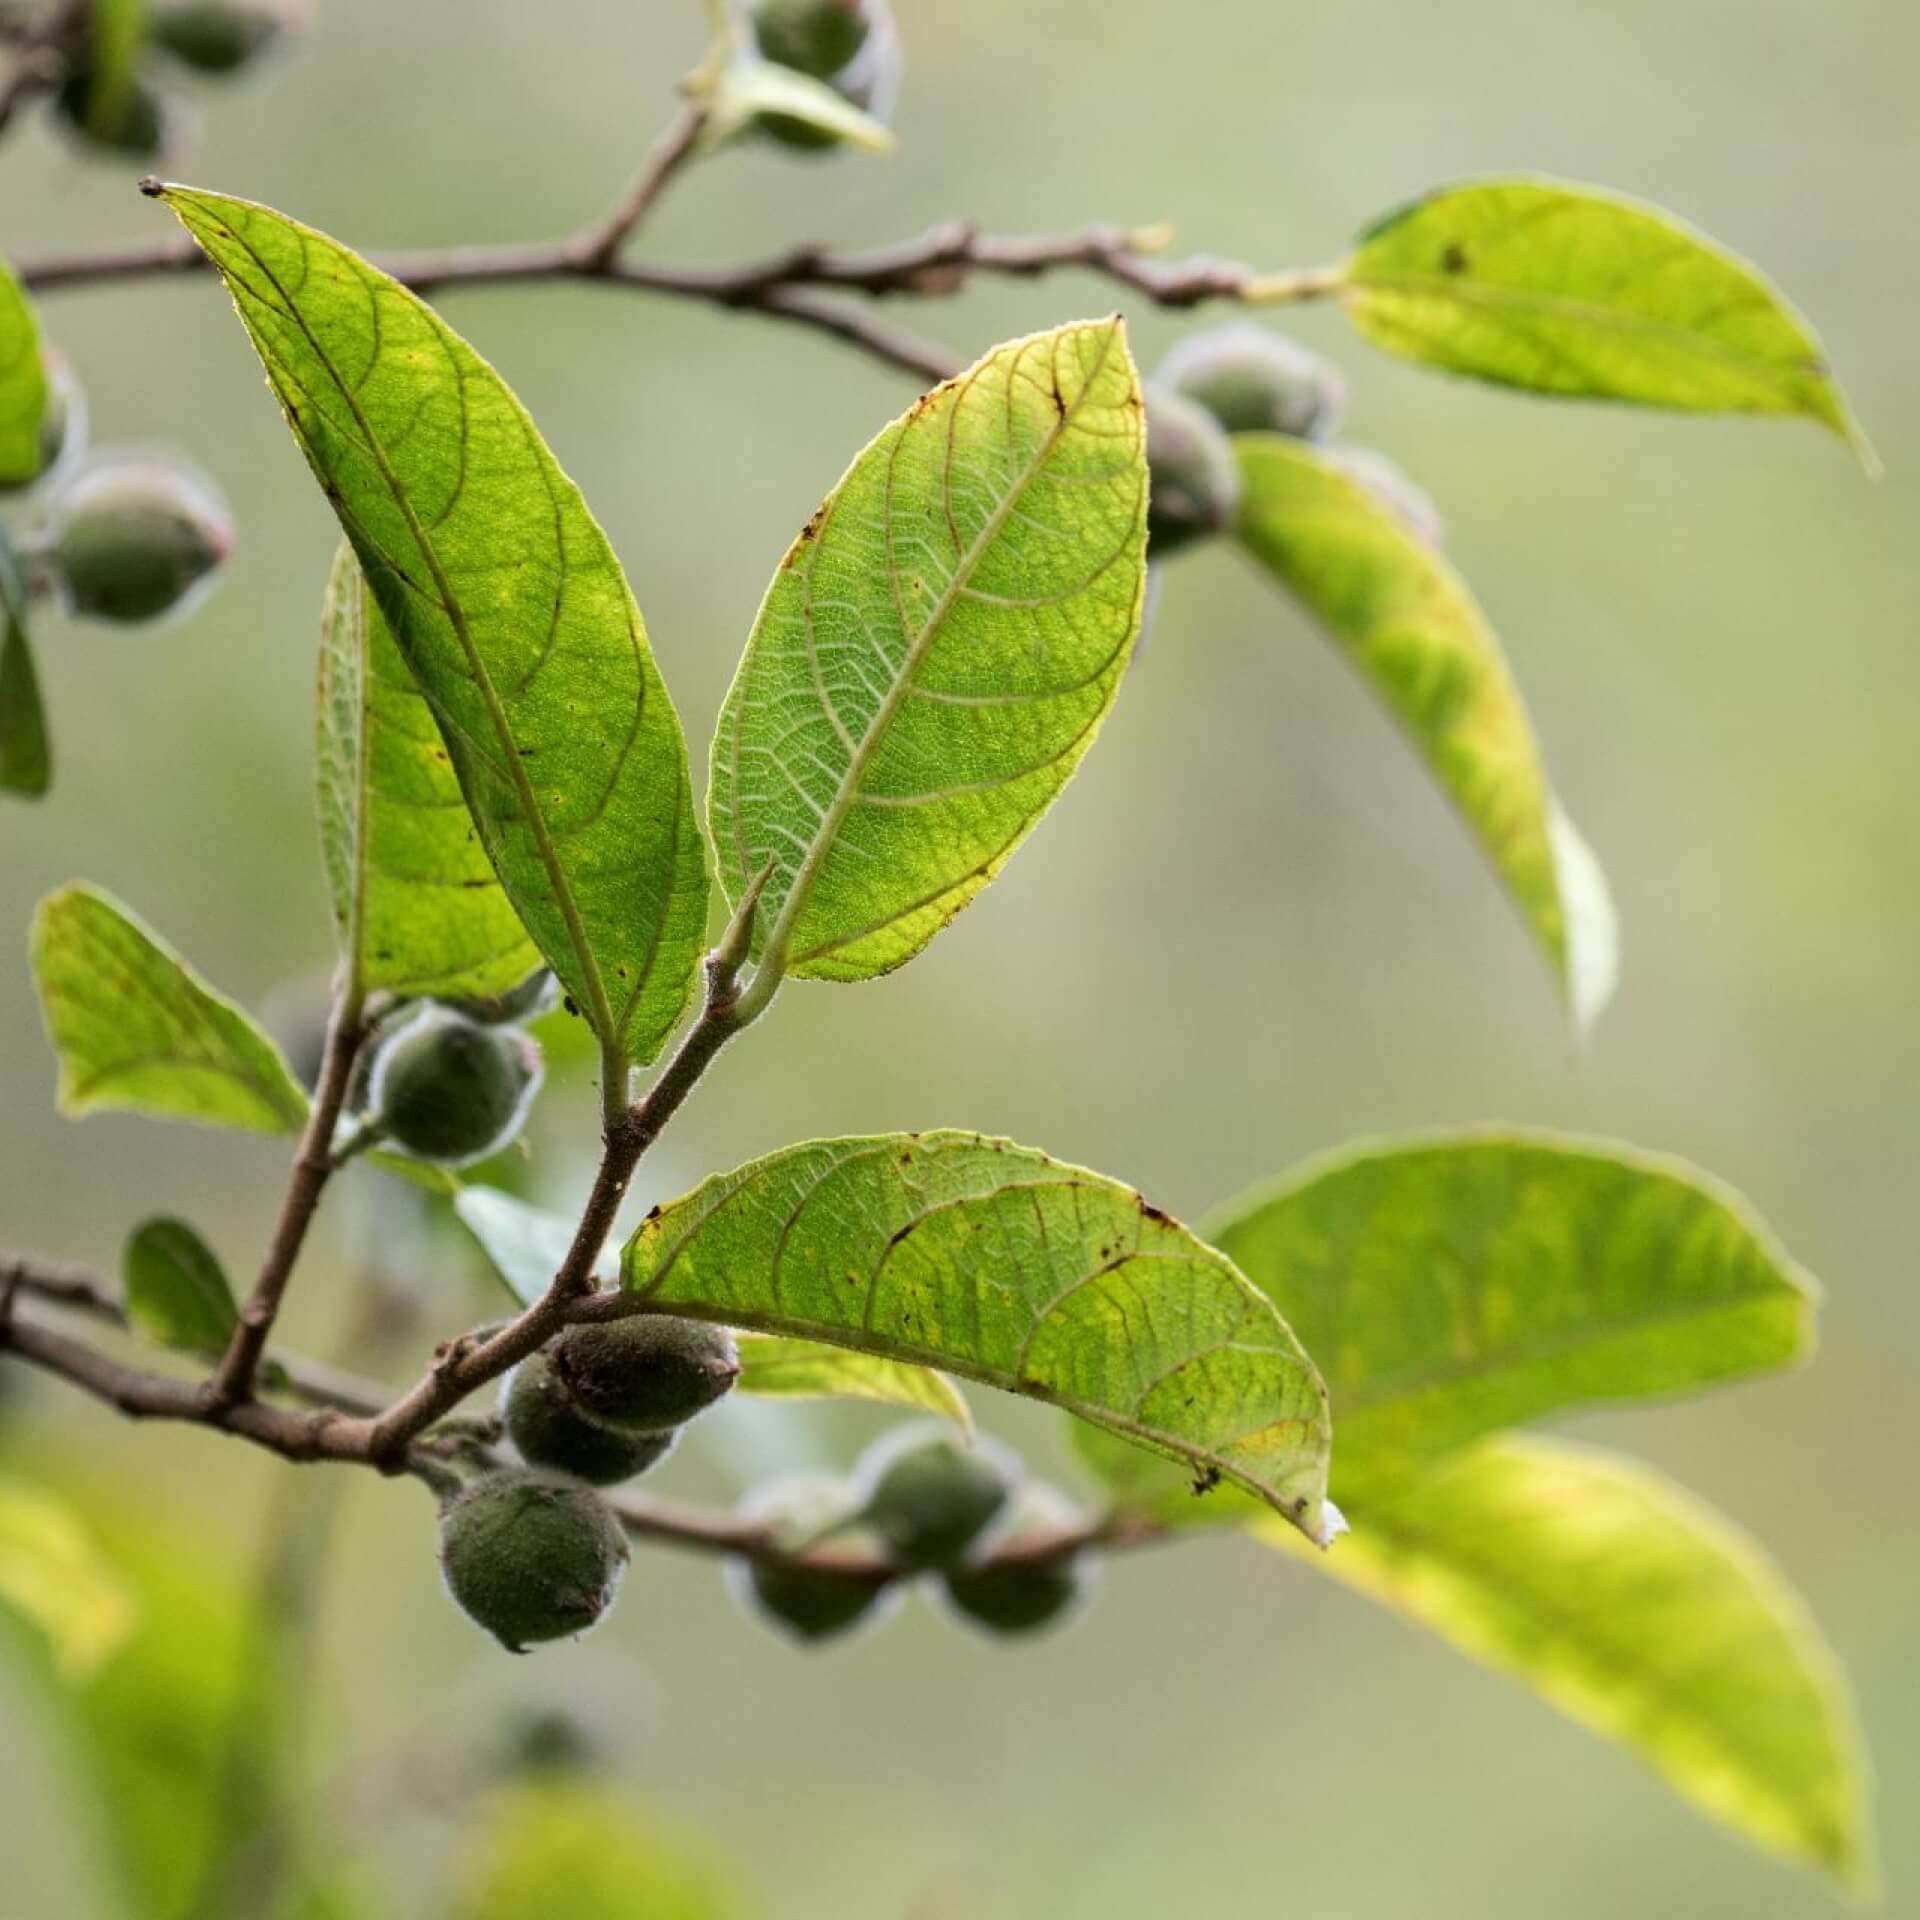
top-left (317, 541), bottom-right (540, 996)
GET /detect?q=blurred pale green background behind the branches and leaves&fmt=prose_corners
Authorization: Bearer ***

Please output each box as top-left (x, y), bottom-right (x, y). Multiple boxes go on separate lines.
top-left (0, 0), bottom-right (1920, 1920)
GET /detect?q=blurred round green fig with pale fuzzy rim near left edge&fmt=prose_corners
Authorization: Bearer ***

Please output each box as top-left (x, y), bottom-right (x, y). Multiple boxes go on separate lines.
top-left (42, 453), bottom-right (234, 626)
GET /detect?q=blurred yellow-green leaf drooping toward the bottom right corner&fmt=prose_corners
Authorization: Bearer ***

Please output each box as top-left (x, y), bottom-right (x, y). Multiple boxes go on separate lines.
top-left (1256, 1436), bottom-right (1876, 1891)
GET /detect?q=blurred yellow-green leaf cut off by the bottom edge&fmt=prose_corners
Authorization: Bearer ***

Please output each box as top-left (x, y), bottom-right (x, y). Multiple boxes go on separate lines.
top-left (449, 1780), bottom-right (741, 1920)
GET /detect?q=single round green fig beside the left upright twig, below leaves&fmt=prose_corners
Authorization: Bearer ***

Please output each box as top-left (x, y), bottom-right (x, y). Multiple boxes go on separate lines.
top-left (367, 1006), bottom-right (545, 1167)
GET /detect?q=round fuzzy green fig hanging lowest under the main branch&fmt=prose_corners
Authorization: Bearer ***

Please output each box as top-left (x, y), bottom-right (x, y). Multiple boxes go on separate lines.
top-left (440, 1469), bottom-right (628, 1653)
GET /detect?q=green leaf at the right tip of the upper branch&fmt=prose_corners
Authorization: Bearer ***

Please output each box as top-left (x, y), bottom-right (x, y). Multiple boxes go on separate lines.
top-left (1342, 179), bottom-right (1859, 456)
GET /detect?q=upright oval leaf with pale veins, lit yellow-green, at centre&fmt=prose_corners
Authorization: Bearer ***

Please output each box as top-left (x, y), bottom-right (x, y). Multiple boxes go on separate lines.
top-left (710, 319), bottom-right (1146, 979)
